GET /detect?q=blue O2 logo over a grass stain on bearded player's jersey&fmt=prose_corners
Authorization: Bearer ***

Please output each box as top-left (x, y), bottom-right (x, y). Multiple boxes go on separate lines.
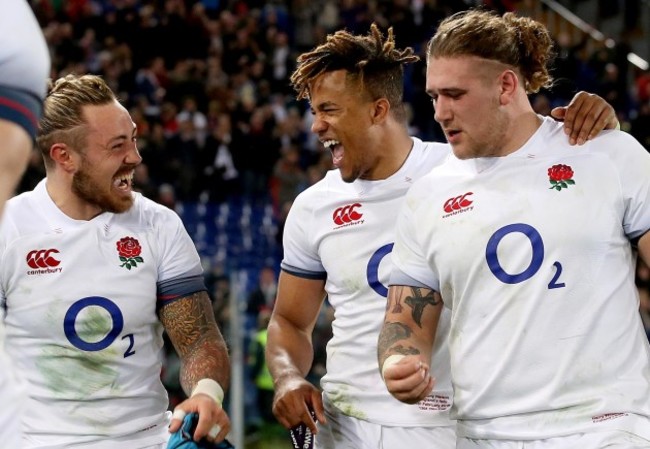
top-left (63, 296), bottom-right (135, 358)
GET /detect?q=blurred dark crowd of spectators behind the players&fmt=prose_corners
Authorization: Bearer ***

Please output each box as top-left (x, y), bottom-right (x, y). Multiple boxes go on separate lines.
top-left (20, 0), bottom-right (650, 434)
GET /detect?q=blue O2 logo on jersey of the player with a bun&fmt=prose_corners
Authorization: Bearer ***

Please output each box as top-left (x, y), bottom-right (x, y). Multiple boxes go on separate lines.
top-left (485, 223), bottom-right (566, 289)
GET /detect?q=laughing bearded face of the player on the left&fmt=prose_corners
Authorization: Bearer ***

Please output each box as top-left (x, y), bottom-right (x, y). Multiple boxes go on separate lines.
top-left (72, 101), bottom-right (142, 213)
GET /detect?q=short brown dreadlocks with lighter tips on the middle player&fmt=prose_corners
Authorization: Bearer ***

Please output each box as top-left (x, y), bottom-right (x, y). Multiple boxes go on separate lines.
top-left (291, 23), bottom-right (420, 119)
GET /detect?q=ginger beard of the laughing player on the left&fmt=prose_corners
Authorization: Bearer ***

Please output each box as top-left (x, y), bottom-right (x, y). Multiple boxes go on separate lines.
top-left (72, 157), bottom-right (133, 214)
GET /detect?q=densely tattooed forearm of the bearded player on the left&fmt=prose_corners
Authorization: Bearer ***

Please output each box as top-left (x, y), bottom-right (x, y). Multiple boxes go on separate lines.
top-left (159, 291), bottom-right (230, 396)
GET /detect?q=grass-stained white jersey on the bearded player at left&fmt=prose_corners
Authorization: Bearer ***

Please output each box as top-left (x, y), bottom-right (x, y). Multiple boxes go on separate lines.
top-left (0, 181), bottom-right (203, 449)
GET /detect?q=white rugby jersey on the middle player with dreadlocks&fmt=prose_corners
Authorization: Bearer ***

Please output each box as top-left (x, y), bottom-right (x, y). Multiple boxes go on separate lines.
top-left (282, 138), bottom-right (451, 426)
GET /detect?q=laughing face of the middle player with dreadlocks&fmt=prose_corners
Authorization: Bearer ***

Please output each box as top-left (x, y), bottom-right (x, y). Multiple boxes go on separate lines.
top-left (309, 70), bottom-right (381, 182)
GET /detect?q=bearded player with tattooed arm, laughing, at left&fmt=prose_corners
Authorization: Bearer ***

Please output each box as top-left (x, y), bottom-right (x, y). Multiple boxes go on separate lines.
top-left (0, 75), bottom-right (230, 449)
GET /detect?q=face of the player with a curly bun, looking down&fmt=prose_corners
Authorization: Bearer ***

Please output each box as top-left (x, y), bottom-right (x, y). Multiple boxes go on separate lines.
top-left (426, 56), bottom-right (508, 159)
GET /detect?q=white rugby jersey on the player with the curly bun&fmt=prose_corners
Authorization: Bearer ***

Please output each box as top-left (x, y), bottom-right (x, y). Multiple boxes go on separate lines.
top-left (390, 119), bottom-right (650, 440)
